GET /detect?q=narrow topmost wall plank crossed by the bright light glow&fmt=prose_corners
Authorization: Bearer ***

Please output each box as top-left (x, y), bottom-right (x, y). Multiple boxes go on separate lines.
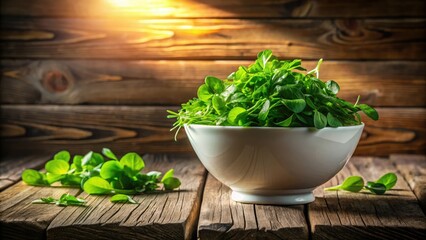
top-left (0, 0), bottom-right (426, 18)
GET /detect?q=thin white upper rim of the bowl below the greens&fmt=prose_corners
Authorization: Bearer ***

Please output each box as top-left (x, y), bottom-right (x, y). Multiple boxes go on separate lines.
top-left (184, 122), bottom-right (365, 131)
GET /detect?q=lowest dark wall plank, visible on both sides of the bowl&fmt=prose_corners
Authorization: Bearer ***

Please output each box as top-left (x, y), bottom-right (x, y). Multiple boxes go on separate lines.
top-left (0, 105), bottom-right (426, 156)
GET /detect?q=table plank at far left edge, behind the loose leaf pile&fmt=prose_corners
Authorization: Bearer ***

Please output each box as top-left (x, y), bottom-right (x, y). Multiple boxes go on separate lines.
top-left (0, 153), bottom-right (50, 191)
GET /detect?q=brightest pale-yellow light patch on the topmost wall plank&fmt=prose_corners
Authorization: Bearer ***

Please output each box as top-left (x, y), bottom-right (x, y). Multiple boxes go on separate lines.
top-left (108, 0), bottom-right (175, 16)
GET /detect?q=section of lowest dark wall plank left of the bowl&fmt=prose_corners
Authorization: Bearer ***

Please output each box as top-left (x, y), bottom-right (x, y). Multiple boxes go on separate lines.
top-left (0, 105), bottom-right (191, 154)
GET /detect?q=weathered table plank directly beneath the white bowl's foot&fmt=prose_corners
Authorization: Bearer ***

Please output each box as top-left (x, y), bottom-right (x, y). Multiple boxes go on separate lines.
top-left (198, 175), bottom-right (308, 240)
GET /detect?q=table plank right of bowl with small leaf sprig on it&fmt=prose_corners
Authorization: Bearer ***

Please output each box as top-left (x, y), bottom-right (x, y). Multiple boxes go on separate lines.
top-left (309, 158), bottom-right (426, 239)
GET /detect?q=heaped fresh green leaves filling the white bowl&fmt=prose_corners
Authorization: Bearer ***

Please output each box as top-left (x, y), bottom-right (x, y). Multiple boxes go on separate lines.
top-left (168, 50), bottom-right (379, 137)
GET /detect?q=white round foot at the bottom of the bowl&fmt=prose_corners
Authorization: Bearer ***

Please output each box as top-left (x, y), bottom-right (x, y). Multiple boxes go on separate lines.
top-left (231, 190), bottom-right (315, 205)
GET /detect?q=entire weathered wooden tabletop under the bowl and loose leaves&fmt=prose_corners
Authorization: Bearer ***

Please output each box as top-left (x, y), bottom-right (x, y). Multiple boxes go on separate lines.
top-left (0, 154), bottom-right (426, 239)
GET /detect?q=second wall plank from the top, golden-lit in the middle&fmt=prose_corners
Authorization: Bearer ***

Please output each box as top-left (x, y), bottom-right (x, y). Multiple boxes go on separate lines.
top-left (0, 18), bottom-right (426, 60)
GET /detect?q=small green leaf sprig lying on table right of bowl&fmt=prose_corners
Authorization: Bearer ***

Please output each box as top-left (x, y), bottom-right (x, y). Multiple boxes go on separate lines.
top-left (324, 173), bottom-right (398, 195)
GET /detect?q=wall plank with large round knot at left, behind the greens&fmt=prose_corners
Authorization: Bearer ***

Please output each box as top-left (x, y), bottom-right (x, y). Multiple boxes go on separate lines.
top-left (0, 60), bottom-right (426, 107)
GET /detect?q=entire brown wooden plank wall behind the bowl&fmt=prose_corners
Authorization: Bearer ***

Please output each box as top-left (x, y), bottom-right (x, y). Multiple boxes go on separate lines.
top-left (0, 0), bottom-right (426, 155)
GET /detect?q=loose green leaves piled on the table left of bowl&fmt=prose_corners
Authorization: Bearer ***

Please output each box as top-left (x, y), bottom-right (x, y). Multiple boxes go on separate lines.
top-left (22, 148), bottom-right (181, 205)
